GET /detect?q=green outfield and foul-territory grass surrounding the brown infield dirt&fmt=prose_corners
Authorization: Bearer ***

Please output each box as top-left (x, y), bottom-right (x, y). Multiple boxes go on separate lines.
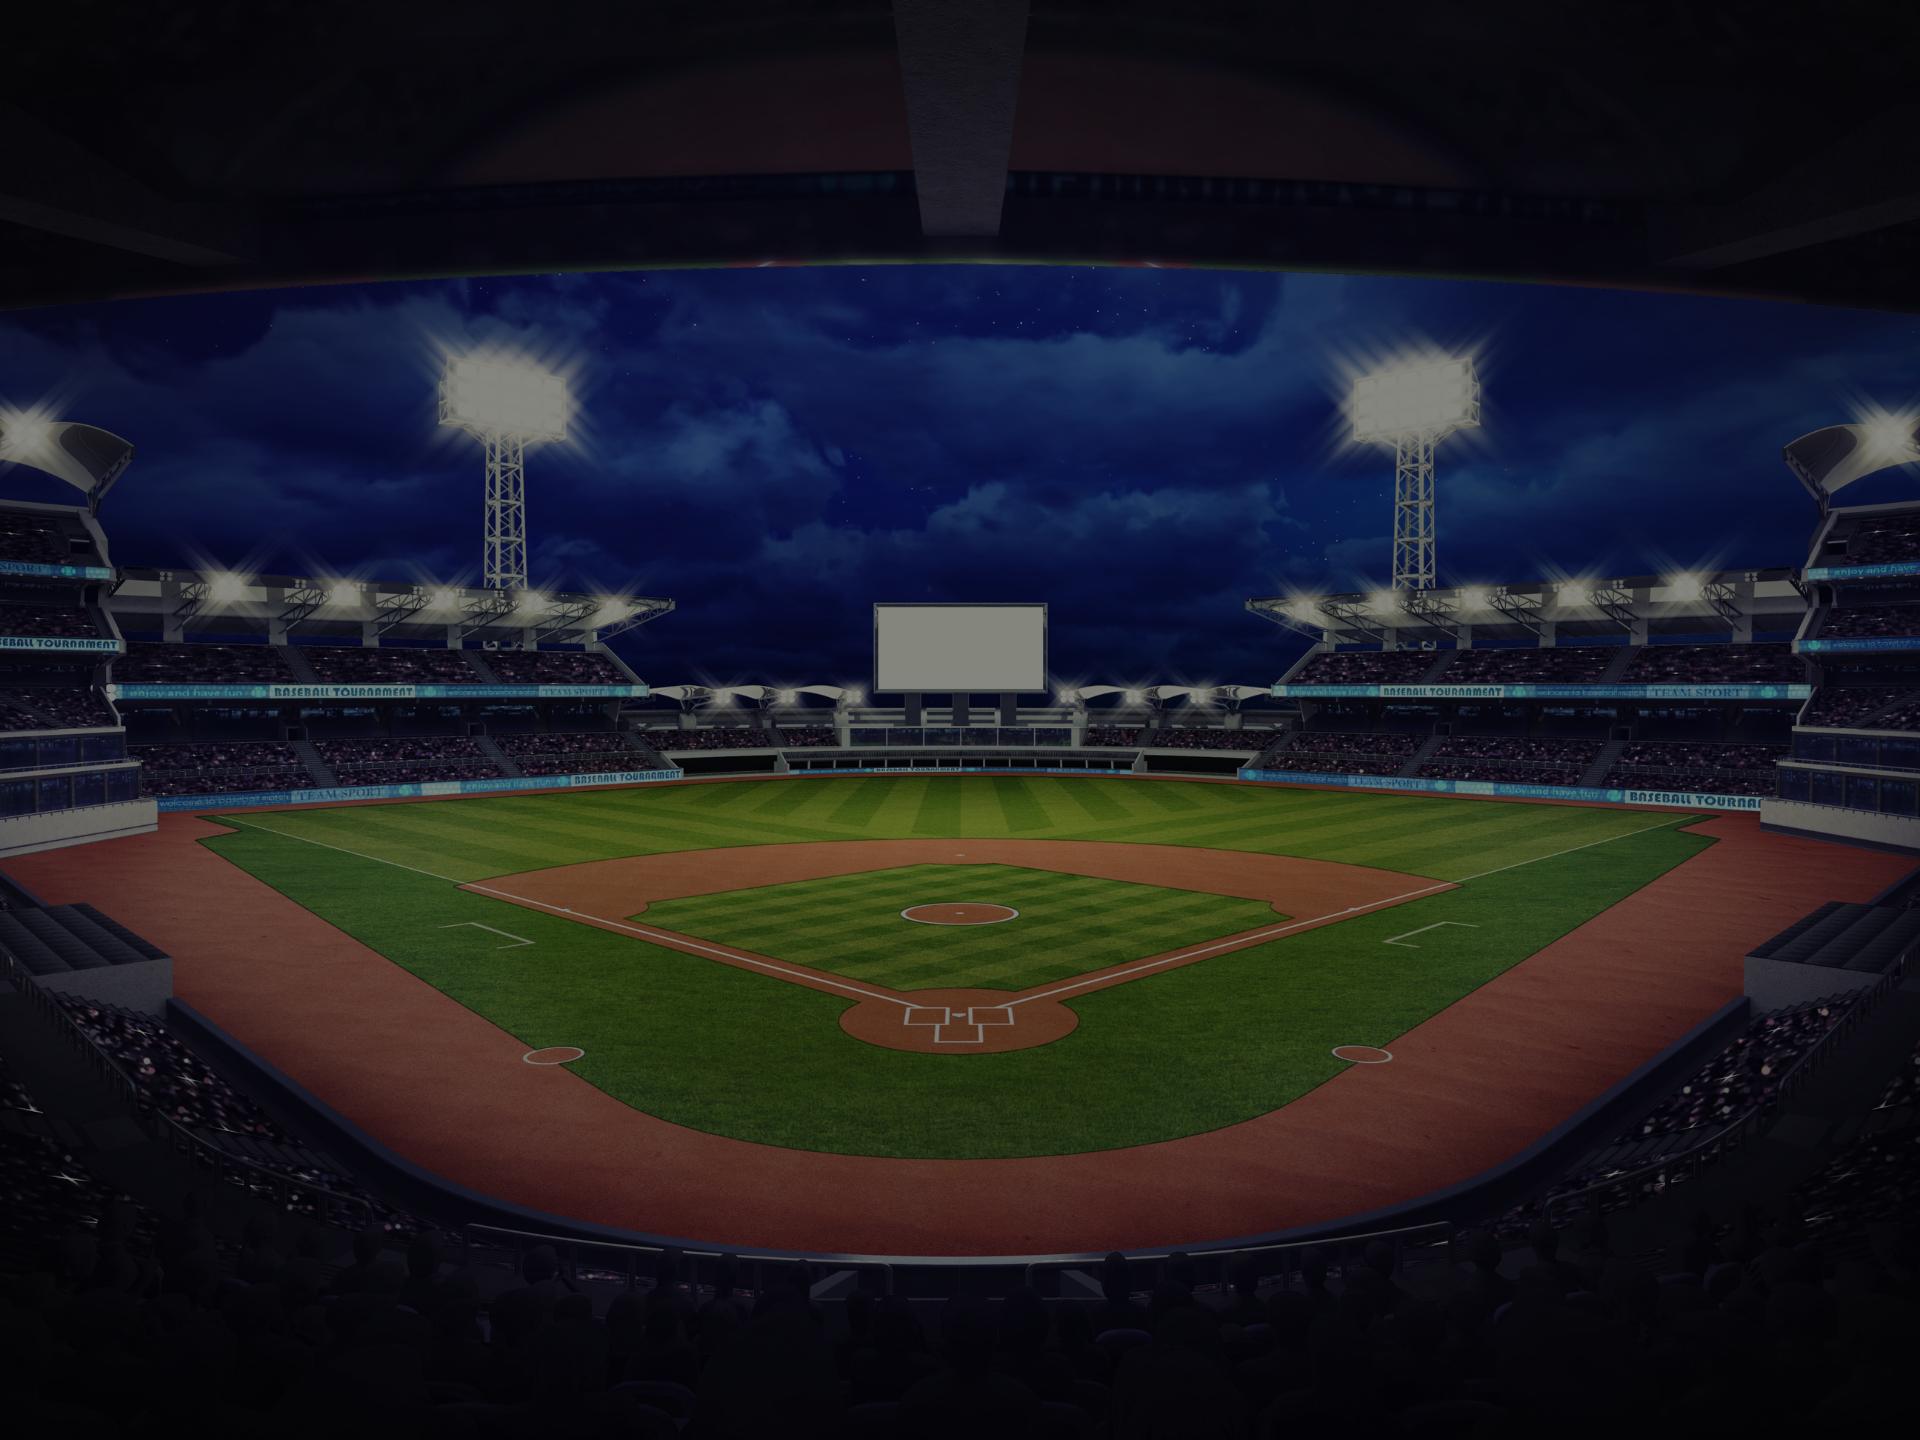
top-left (207, 778), bottom-right (1711, 1158)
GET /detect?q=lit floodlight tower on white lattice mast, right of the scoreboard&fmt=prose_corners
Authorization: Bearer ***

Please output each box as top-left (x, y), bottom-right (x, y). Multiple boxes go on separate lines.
top-left (1348, 357), bottom-right (1480, 589)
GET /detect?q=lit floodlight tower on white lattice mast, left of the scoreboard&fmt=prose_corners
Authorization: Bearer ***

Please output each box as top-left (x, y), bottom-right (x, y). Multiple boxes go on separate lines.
top-left (440, 355), bottom-right (568, 589)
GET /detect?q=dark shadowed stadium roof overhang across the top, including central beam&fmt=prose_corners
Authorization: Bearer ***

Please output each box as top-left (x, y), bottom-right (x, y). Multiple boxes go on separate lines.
top-left (0, 0), bottom-right (1920, 309)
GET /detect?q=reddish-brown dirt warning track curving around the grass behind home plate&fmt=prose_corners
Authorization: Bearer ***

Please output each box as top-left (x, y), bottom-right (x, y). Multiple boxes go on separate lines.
top-left (6, 816), bottom-right (1912, 1256)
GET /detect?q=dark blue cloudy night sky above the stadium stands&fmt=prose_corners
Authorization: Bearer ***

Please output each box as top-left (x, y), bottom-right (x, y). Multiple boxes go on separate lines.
top-left (0, 265), bottom-right (1920, 684)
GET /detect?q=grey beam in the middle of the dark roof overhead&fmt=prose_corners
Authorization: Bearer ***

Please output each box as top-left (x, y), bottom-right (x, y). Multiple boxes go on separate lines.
top-left (893, 0), bottom-right (1027, 238)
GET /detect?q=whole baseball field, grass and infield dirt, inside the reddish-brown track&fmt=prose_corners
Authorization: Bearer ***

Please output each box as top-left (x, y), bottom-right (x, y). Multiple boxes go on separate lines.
top-left (200, 776), bottom-right (1715, 1160)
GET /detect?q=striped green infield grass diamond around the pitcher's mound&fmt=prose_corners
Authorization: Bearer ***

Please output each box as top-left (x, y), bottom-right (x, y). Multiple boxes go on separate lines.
top-left (641, 864), bottom-right (1281, 991)
